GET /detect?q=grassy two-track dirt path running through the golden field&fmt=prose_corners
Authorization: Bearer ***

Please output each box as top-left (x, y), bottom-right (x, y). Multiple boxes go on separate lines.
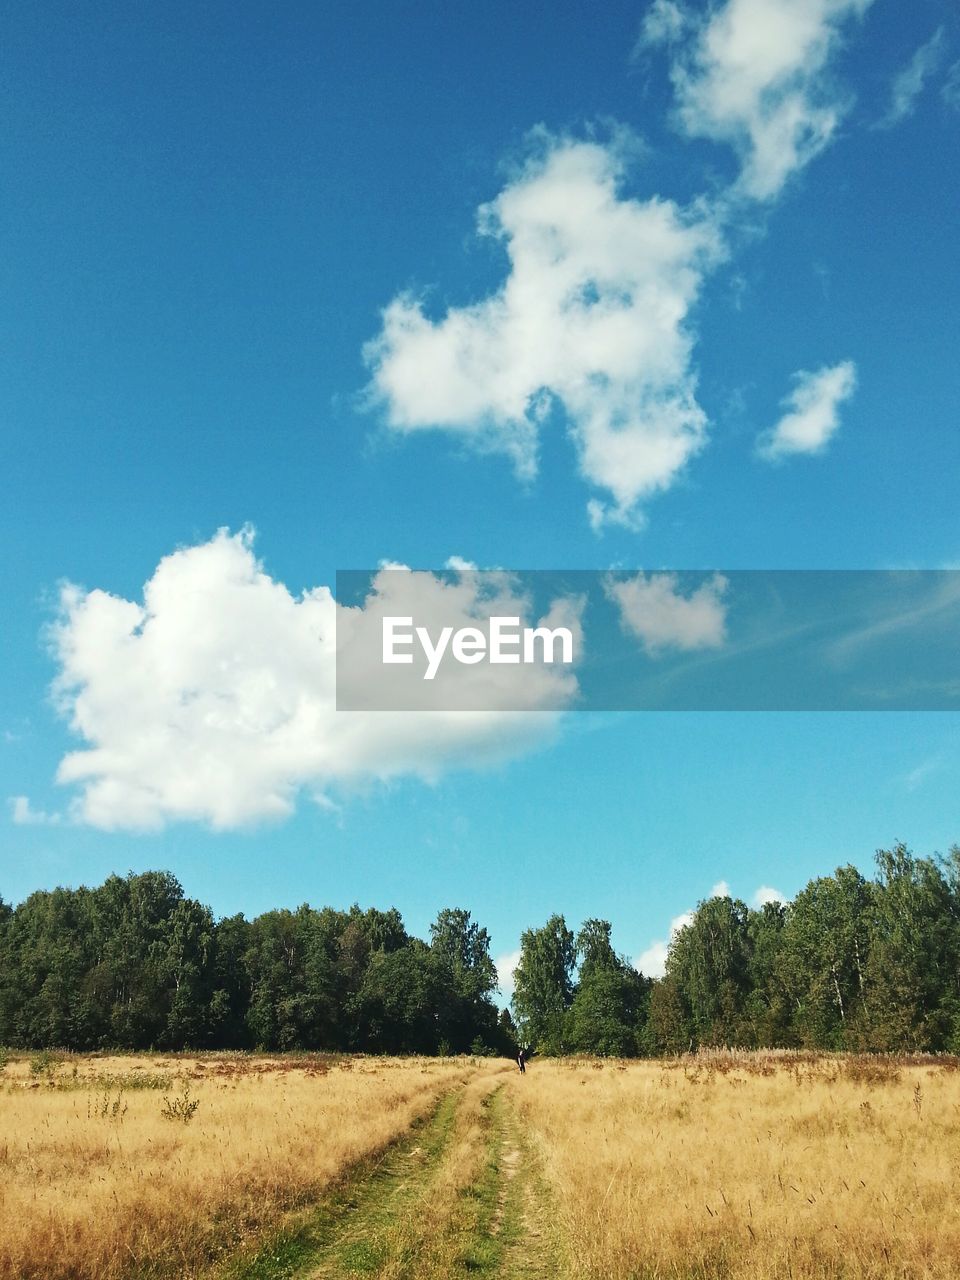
top-left (221, 1076), bottom-right (562, 1280)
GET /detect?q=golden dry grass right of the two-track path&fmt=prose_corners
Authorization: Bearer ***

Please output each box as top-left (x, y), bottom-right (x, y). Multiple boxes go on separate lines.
top-left (508, 1053), bottom-right (960, 1280)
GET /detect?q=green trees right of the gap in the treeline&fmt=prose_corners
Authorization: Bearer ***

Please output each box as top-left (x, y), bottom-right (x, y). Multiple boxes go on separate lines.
top-left (513, 845), bottom-right (960, 1055)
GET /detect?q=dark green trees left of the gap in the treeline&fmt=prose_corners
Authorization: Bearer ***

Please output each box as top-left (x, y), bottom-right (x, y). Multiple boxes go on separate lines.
top-left (0, 872), bottom-right (515, 1053)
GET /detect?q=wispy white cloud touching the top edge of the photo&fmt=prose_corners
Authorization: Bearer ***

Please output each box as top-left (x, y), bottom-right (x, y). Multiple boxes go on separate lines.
top-left (645, 0), bottom-right (872, 200)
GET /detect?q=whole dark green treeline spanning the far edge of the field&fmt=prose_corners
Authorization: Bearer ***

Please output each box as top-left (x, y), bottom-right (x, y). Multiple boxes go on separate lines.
top-left (0, 845), bottom-right (960, 1056)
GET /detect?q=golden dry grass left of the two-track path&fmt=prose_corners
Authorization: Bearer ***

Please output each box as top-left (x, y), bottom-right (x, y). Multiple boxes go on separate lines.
top-left (0, 1056), bottom-right (492, 1280)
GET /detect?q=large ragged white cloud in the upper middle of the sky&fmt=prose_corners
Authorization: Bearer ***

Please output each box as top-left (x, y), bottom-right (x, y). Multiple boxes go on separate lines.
top-left (365, 132), bottom-right (722, 525)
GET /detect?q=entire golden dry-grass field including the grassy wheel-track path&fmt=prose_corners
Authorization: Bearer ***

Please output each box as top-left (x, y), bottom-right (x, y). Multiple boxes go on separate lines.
top-left (0, 1053), bottom-right (960, 1280)
